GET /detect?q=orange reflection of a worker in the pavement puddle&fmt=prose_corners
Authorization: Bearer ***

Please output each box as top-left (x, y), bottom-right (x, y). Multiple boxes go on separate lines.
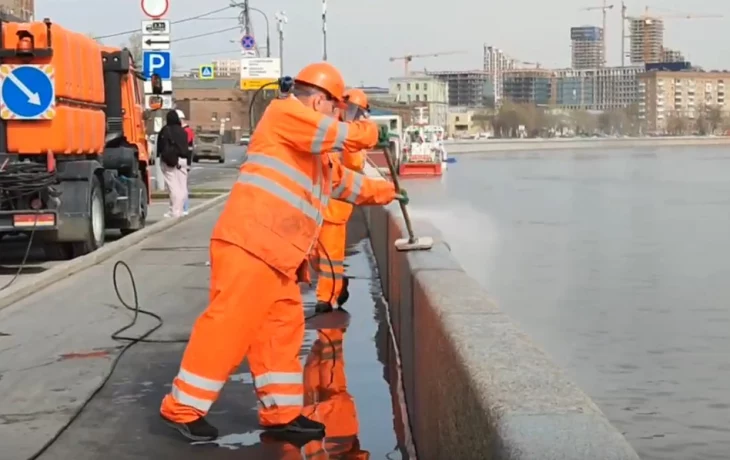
top-left (263, 329), bottom-right (370, 460)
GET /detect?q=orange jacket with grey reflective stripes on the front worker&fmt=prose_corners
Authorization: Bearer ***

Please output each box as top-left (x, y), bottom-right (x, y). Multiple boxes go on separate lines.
top-left (211, 96), bottom-right (395, 280)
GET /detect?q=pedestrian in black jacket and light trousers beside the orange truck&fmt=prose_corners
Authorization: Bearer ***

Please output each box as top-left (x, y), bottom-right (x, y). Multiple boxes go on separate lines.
top-left (157, 110), bottom-right (190, 217)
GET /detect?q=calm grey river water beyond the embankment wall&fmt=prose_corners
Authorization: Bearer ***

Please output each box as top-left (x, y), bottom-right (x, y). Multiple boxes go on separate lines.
top-left (403, 147), bottom-right (730, 460)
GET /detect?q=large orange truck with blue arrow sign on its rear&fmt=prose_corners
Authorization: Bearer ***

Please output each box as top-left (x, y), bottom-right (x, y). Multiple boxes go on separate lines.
top-left (0, 19), bottom-right (151, 259)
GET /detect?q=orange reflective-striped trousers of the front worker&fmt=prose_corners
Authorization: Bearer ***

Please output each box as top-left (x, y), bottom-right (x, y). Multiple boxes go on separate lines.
top-left (160, 240), bottom-right (304, 426)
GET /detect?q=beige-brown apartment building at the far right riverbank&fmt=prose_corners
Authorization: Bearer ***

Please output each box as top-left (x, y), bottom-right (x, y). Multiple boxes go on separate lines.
top-left (638, 70), bottom-right (730, 133)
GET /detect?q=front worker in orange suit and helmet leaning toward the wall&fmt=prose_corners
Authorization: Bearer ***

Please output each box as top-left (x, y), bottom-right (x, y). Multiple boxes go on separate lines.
top-left (160, 62), bottom-right (407, 441)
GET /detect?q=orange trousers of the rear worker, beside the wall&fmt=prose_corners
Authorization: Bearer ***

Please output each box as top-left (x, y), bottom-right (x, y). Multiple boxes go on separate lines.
top-left (314, 220), bottom-right (347, 305)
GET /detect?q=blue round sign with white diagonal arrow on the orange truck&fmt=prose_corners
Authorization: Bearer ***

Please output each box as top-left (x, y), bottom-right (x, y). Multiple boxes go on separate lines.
top-left (0, 65), bottom-right (56, 120)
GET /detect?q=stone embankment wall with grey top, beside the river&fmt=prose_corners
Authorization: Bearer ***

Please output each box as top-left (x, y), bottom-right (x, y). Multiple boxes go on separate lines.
top-left (364, 200), bottom-right (639, 460)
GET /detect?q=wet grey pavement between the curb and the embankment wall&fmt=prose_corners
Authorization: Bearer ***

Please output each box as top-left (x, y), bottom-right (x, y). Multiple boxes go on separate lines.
top-left (0, 201), bottom-right (407, 460)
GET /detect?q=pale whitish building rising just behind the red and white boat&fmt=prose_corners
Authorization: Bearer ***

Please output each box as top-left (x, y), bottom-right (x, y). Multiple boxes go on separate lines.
top-left (388, 74), bottom-right (449, 126)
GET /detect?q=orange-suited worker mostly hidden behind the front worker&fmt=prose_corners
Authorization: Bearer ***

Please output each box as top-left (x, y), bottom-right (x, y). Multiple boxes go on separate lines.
top-left (315, 89), bottom-right (370, 313)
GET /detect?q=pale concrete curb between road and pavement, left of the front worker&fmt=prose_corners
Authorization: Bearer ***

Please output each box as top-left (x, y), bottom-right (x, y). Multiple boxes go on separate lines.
top-left (0, 193), bottom-right (228, 310)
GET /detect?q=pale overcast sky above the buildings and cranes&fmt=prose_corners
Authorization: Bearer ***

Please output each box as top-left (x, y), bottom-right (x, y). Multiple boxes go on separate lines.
top-left (36, 0), bottom-right (730, 86)
